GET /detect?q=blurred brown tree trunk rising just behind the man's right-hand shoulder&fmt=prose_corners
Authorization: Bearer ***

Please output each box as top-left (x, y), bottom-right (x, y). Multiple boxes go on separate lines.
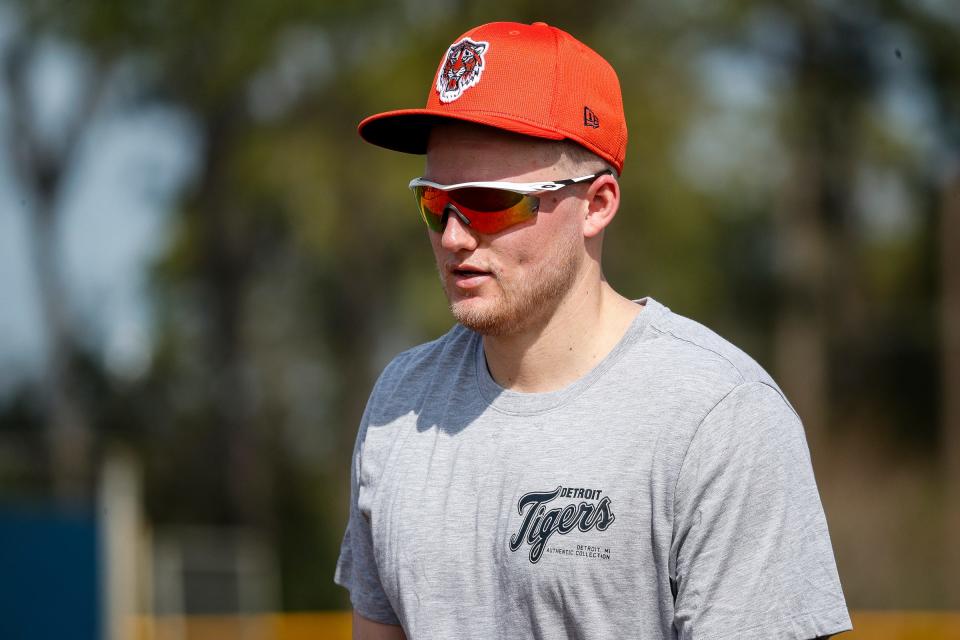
top-left (775, 6), bottom-right (877, 448)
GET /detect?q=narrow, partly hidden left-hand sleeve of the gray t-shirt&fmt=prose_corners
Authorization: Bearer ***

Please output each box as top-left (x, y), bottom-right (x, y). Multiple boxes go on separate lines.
top-left (334, 388), bottom-right (400, 624)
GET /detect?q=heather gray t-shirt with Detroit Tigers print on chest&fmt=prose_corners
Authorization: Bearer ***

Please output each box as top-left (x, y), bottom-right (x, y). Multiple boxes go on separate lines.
top-left (335, 298), bottom-right (851, 640)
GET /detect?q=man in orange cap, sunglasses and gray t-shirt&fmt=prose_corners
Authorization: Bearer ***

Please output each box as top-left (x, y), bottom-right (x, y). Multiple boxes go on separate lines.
top-left (336, 23), bottom-right (850, 639)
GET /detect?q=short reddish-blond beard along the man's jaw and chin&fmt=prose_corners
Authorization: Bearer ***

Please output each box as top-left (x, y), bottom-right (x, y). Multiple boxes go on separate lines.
top-left (441, 231), bottom-right (583, 336)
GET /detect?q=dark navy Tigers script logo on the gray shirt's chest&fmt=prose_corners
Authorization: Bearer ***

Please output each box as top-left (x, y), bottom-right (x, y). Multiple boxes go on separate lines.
top-left (510, 486), bottom-right (616, 564)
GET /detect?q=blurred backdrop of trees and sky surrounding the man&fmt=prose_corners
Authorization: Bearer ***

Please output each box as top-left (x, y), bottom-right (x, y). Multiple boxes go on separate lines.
top-left (0, 0), bottom-right (960, 638)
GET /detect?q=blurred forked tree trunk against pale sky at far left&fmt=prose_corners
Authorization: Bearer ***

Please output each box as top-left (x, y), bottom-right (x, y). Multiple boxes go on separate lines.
top-left (0, 6), bottom-right (110, 503)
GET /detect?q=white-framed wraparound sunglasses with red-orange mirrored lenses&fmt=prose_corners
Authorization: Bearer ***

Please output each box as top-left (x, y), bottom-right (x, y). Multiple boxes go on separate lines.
top-left (410, 169), bottom-right (612, 233)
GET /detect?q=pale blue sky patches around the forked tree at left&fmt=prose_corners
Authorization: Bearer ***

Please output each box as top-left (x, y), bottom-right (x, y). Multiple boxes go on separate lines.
top-left (0, 32), bottom-right (196, 396)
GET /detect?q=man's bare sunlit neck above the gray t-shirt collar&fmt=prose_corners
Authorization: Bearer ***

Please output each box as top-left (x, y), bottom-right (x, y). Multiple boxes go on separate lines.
top-left (483, 277), bottom-right (642, 393)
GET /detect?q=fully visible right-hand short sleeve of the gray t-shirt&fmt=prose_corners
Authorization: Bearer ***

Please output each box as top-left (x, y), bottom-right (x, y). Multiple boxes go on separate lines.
top-left (671, 382), bottom-right (851, 640)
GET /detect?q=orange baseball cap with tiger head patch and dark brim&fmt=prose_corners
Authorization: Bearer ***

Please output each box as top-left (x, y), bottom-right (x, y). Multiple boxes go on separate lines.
top-left (357, 22), bottom-right (627, 173)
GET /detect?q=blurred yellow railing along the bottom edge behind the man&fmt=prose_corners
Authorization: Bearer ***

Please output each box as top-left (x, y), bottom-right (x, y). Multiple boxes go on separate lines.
top-left (130, 611), bottom-right (960, 640)
